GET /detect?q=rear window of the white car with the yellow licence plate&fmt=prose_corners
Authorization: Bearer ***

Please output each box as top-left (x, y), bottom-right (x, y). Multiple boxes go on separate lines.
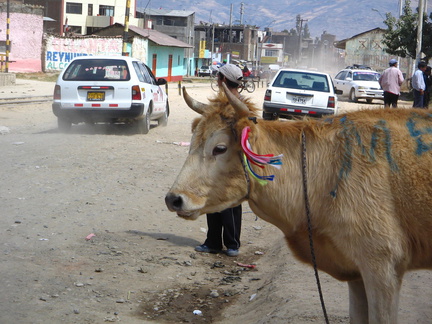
top-left (63, 59), bottom-right (130, 81)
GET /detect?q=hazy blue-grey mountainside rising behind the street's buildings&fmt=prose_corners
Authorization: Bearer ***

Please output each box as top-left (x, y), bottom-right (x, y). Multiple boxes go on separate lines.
top-left (137, 0), bottom-right (432, 40)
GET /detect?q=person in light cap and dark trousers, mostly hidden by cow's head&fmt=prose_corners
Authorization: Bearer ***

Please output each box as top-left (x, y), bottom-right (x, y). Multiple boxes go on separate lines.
top-left (195, 64), bottom-right (243, 257)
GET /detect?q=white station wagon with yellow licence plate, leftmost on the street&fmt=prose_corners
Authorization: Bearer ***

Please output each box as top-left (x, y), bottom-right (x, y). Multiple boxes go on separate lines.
top-left (52, 56), bottom-right (169, 134)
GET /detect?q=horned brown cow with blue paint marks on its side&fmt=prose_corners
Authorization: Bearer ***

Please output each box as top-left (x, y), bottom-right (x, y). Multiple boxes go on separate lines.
top-left (165, 84), bottom-right (432, 324)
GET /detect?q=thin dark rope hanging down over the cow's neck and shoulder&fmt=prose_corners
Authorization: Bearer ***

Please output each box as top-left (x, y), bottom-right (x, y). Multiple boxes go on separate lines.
top-left (302, 131), bottom-right (329, 324)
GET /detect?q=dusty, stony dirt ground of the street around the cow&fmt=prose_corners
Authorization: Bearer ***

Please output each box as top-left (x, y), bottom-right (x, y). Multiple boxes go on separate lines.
top-left (0, 79), bottom-right (432, 324)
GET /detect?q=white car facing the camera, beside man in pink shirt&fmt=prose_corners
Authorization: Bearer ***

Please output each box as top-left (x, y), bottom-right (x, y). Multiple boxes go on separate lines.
top-left (333, 66), bottom-right (384, 103)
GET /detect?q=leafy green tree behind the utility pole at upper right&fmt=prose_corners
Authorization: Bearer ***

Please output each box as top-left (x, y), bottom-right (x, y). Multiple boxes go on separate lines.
top-left (383, 0), bottom-right (432, 61)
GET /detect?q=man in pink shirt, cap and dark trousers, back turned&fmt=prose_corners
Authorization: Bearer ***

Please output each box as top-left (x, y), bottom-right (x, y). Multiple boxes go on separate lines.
top-left (379, 59), bottom-right (404, 108)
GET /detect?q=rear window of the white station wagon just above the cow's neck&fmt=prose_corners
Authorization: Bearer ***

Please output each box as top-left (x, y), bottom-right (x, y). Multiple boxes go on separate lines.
top-left (273, 71), bottom-right (330, 92)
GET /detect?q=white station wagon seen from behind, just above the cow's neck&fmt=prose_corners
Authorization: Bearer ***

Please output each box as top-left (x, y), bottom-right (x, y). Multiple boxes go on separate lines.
top-left (263, 69), bottom-right (338, 120)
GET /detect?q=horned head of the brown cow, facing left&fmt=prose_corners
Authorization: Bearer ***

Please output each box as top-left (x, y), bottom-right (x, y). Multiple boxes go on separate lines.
top-left (165, 84), bottom-right (257, 220)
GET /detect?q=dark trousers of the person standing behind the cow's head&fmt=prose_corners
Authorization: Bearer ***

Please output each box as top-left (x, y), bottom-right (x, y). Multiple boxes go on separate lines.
top-left (204, 205), bottom-right (242, 250)
